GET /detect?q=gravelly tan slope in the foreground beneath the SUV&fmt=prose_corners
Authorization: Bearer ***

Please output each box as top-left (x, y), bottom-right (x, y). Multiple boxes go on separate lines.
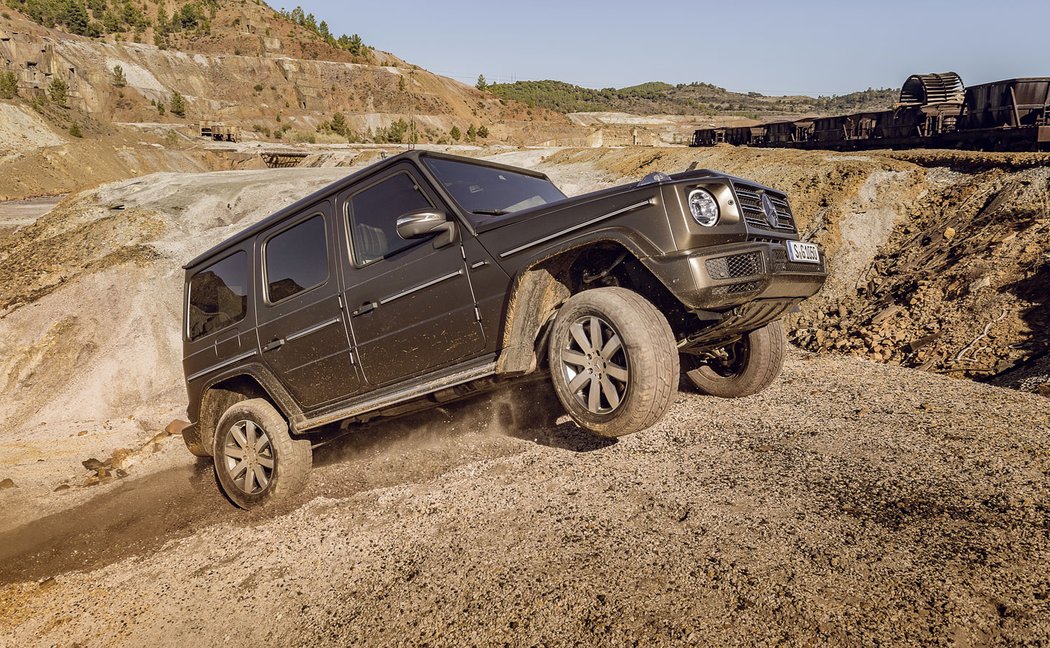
top-left (0, 352), bottom-right (1050, 646)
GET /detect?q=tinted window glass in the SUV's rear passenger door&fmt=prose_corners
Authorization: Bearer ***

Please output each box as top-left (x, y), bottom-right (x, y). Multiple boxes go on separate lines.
top-left (265, 214), bottom-right (329, 304)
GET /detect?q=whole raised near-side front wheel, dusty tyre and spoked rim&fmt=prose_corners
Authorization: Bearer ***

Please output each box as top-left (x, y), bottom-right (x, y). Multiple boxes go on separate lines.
top-left (547, 288), bottom-right (679, 437)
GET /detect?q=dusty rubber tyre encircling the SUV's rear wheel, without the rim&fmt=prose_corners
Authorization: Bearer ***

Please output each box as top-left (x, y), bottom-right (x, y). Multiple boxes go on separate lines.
top-left (212, 398), bottom-right (313, 508)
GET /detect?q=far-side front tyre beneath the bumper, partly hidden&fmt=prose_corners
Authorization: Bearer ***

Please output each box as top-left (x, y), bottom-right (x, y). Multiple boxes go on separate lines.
top-left (683, 320), bottom-right (785, 398)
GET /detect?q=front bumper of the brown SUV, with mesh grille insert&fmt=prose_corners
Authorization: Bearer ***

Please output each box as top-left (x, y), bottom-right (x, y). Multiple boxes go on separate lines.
top-left (646, 242), bottom-right (827, 312)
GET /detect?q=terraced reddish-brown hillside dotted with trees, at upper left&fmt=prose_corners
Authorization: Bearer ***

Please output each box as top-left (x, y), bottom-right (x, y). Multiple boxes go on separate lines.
top-left (0, 0), bottom-right (588, 144)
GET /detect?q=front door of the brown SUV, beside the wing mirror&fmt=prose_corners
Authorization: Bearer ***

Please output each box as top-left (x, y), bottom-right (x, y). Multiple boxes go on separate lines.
top-left (342, 164), bottom-right (485, 388)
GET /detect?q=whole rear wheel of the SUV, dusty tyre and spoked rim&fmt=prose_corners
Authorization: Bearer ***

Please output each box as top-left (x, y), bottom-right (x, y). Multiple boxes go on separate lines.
top-left (212, 398), bottom-right (313, 508)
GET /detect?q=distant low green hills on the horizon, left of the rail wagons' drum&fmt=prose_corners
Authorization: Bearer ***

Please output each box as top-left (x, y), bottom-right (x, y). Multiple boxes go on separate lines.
top-left (486, 81), bottom-right (898, 118)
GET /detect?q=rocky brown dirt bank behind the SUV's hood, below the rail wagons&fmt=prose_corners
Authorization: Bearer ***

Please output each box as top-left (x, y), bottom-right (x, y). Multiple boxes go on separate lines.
top-left (549, 146), bottom-right (1050, 391)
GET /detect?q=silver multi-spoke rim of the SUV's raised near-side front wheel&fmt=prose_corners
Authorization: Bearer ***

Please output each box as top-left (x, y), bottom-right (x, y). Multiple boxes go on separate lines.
top-left (561, 315), bottom-right (630, 414)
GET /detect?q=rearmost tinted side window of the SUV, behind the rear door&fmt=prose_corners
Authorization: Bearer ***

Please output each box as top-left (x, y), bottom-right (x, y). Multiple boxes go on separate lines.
top-left (187, 250), bottom-right (248, 340)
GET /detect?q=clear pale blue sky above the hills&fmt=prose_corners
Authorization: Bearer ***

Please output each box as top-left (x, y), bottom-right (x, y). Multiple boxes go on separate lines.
top-left (283, 0), bottom-right (1050, 96)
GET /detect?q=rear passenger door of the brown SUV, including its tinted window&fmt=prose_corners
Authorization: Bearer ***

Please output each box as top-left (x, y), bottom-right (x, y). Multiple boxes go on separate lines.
top-left (256, 202), bottom-right (361, 409)
